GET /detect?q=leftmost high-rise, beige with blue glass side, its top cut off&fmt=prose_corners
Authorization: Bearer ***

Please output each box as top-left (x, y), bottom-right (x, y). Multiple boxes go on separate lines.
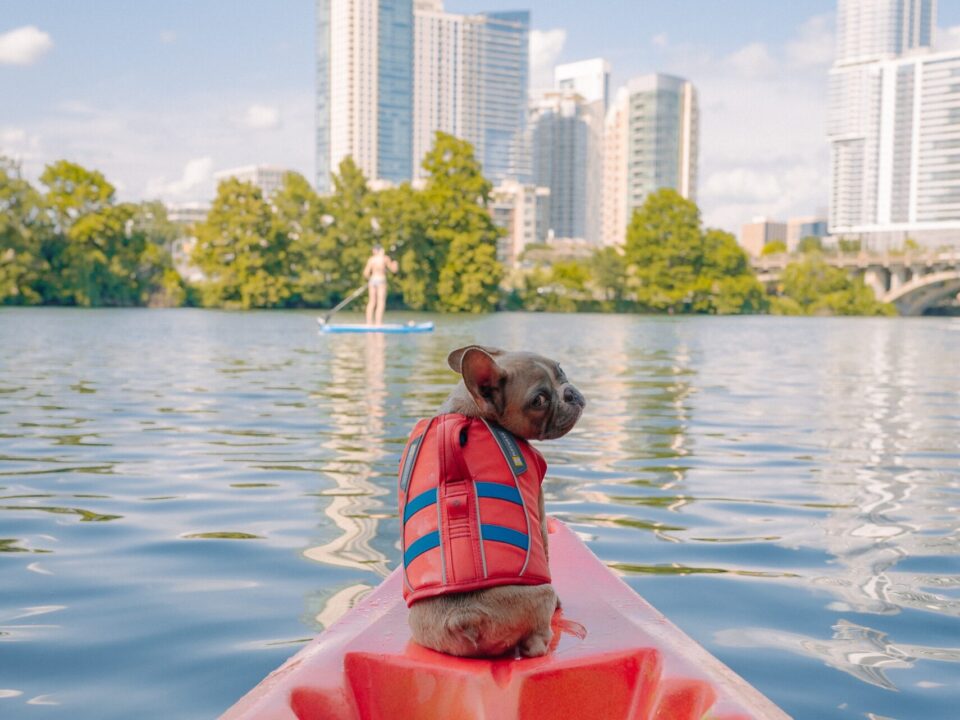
top-left (316, 0), bottom-right (413, 192)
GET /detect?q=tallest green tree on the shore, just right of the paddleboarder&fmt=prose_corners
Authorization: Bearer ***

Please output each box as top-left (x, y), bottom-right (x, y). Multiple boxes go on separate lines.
top-left (423, 132), bottom-right (503, 312)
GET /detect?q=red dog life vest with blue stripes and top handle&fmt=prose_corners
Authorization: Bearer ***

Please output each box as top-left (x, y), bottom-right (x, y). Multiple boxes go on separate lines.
top-left (399, 414), bottom-right (550, 606)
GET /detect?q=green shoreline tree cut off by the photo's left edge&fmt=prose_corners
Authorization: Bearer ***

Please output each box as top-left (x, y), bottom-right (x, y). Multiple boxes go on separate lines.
top-left (0, 157), bottom-right (51, 305)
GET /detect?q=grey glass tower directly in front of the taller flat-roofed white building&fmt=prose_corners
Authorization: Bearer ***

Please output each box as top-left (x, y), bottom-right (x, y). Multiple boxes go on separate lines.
top-left (530, 90), bottom-right (603, 243)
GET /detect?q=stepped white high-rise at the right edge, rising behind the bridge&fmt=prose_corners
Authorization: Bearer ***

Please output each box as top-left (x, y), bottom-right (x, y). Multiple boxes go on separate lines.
top-left (827, 0), bottom-right (960, 247)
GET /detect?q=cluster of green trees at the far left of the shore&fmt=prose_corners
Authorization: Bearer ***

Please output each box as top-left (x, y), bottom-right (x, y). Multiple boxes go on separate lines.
top-left (0, 161), bottom-right (183, 307)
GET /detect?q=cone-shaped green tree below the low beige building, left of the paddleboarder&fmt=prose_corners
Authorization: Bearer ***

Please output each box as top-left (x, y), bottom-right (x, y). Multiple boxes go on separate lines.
top-left (193, 178), bottom-right (292, 310)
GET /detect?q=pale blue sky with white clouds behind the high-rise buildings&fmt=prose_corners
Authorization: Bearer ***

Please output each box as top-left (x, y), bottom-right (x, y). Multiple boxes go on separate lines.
top-left (0, 0), bottom-right (960, 230)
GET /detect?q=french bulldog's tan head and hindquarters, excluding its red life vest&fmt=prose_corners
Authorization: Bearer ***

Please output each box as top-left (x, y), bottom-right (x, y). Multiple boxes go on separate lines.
top-left (409, 345), bottom-right (586, 657)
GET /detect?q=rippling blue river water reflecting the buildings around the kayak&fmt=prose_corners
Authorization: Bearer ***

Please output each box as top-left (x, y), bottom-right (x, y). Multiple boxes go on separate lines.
top-left (0, 309), bottom-right (960, 720)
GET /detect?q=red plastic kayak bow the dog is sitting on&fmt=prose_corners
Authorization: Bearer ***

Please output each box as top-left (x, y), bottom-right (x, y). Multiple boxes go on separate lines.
top-left (222, 520), bottom-right (788, 720)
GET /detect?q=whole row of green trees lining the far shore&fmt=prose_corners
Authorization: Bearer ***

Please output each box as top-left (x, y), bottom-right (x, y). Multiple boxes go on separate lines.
top-left (0, 133), bottom-right (896, 315)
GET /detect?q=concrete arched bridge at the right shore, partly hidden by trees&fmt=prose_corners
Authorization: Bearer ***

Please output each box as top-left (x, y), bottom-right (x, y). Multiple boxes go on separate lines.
top-left (751, 250), bottom-right (960, 315)
